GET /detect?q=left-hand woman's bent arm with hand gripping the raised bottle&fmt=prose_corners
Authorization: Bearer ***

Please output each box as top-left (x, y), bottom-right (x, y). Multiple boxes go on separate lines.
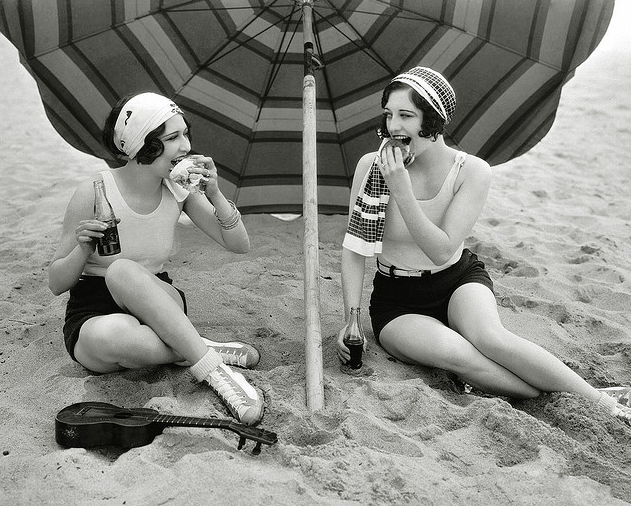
top-left (48, 181), bottom-right (106, 295)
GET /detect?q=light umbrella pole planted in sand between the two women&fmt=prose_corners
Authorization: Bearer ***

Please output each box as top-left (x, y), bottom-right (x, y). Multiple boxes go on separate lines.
top-left (302, 0), bottom-right (324, 413)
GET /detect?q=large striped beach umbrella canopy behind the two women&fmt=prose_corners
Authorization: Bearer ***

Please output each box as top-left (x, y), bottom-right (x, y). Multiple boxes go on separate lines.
top-left (0, 0), bottom-right (614, 213)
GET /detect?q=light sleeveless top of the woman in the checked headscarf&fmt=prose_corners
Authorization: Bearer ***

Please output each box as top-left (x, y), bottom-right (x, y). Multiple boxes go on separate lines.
top-left (379, 151), bottom-right (467, 270)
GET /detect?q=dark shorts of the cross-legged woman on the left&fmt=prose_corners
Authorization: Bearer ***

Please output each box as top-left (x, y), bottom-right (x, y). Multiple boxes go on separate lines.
top-left (63, 272), bottom-right (187, 362)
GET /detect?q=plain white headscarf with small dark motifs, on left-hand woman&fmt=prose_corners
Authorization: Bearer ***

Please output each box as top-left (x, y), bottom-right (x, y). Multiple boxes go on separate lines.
top-left (114, 93), bottom-right (182, 160)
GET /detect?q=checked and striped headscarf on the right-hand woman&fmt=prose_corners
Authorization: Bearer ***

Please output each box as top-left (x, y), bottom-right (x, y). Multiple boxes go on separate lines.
top-left (390, 67), bottom-right (456, 124)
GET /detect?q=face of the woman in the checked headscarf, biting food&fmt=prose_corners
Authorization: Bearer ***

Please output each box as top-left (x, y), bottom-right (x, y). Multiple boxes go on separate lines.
top-left (383, 88), bottom-right (428, 154)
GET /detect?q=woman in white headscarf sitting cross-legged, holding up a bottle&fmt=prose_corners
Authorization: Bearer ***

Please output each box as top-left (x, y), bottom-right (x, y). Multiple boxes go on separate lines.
top-left (49, 93), bottom-right (264, 425)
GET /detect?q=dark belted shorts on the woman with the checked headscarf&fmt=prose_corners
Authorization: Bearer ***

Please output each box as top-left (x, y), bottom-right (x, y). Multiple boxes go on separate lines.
top-left (370, 249), bottom-right (493, 342)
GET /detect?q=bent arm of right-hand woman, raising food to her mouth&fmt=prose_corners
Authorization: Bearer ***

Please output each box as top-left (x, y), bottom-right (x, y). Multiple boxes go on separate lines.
top-left (384, 149), bottom-right (491, 265)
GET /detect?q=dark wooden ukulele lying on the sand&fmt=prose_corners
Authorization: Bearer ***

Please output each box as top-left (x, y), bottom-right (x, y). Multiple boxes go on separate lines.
top-left (55, 402), bottom-right (278, 455)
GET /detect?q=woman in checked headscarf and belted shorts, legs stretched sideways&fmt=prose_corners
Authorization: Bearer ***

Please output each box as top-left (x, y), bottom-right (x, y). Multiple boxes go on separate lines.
top-left (337, 67), bottom-right (631, 422)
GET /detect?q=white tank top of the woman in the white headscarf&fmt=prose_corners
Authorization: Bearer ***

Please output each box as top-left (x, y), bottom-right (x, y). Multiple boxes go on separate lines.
top-left (83, 170), bottom-right (180, 276)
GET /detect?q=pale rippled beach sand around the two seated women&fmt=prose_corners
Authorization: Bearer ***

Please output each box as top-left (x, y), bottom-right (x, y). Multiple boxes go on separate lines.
top-left (0, 2), bottom-right (631, 506)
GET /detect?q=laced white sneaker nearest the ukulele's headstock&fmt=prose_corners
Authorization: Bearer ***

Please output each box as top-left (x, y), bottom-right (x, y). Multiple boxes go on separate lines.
top-left (206, 364), bottom-right (264, 425)
